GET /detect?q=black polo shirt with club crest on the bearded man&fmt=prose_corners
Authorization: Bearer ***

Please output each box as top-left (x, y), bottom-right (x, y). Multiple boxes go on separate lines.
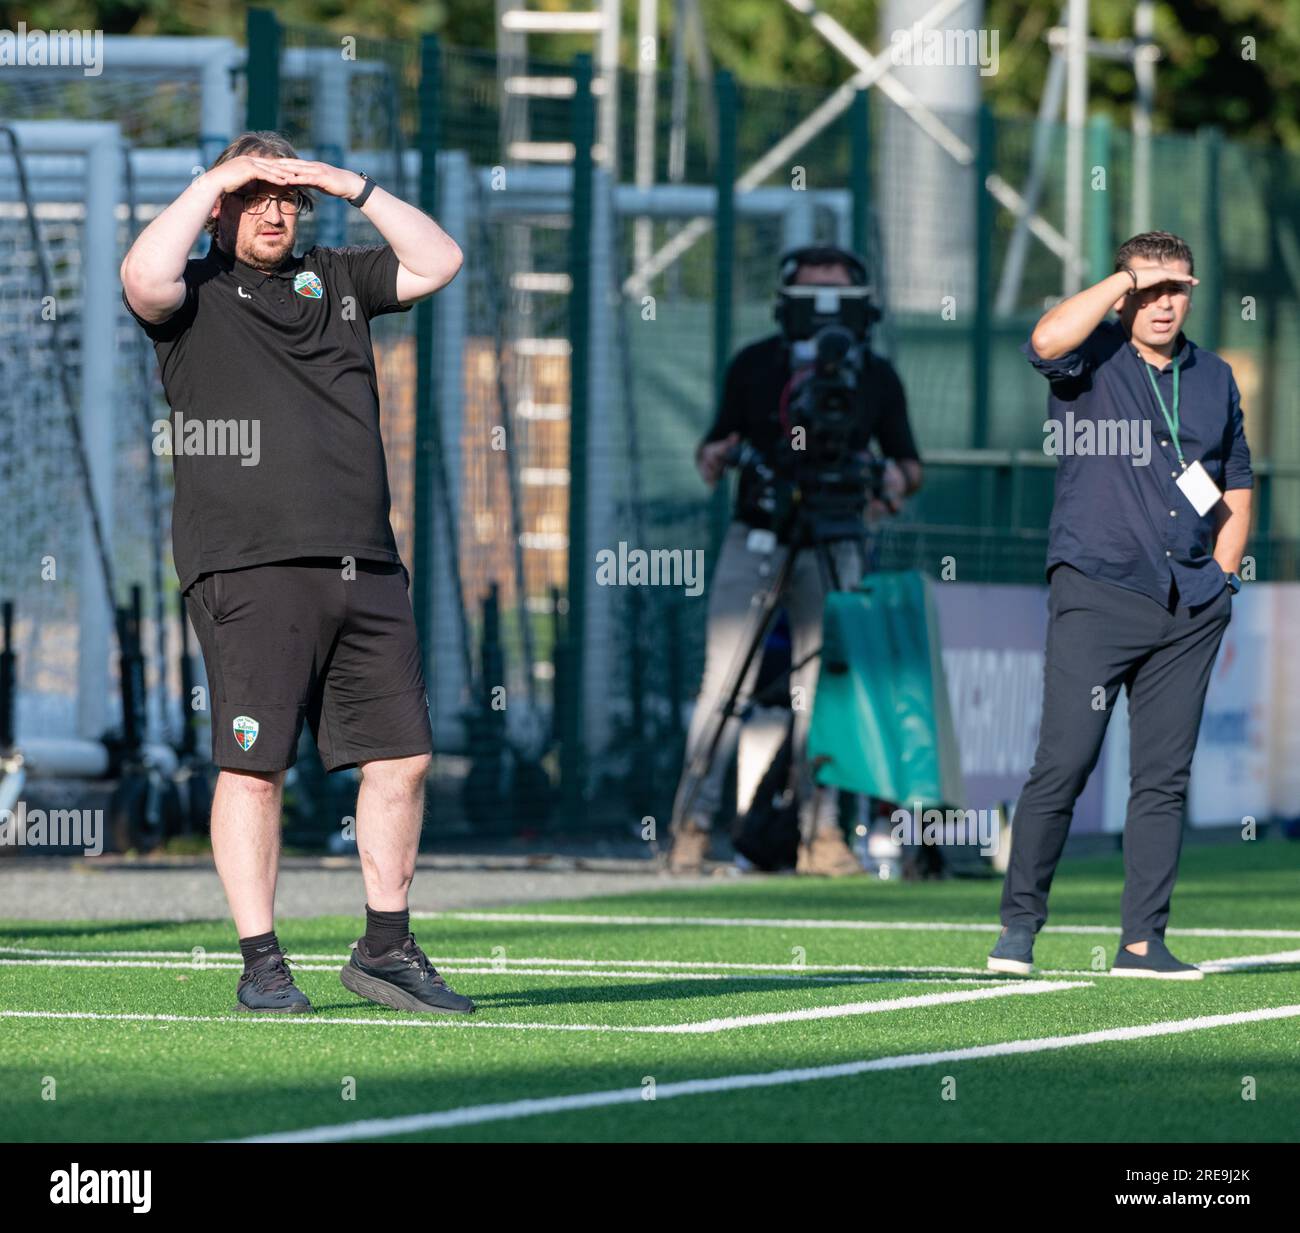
top-left (122, 245), bottom-right (411, 590)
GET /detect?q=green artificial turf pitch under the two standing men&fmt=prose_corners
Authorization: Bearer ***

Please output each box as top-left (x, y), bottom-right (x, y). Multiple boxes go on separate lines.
top-left (0, 842), bottom-right (1300, 1142)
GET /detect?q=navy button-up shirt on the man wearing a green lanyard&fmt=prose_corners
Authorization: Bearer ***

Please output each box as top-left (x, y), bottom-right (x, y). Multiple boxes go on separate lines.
top-left (1021, 321), bottom-right (1255, 606)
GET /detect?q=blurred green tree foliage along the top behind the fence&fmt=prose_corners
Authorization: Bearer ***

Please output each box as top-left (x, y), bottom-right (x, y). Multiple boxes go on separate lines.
top-left (0, 0), bottom-right (1300, 148)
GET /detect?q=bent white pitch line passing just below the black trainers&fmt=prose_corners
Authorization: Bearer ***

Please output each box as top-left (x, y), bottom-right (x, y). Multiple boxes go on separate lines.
top-left (0, 981), bottom-right (1091, 1035)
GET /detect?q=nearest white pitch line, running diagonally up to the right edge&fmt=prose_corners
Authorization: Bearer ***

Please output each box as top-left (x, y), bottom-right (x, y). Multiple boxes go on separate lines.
top-left (228, 1005), bottom-right (1300, 1143)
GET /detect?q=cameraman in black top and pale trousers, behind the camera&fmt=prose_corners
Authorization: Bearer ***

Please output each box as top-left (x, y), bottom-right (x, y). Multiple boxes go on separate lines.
top-left (668, 246), bottom-right (920, 875)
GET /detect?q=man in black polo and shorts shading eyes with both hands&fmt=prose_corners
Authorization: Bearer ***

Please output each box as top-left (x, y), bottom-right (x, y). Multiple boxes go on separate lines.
top-left (121, 133), bottom-right (473, 1013)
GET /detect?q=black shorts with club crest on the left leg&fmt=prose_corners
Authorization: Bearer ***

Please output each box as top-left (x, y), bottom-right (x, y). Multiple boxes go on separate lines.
top-left (185, 558), bottom-right (433, 771)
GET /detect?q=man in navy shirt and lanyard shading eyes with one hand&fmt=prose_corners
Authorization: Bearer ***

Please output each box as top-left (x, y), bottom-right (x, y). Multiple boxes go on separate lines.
top-left (988, 232), bottom-right (1253, 979)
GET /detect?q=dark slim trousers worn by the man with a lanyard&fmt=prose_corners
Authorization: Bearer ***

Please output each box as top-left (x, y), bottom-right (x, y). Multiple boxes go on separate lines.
top-left (1002, 564), bottom-right (1232, 947)
